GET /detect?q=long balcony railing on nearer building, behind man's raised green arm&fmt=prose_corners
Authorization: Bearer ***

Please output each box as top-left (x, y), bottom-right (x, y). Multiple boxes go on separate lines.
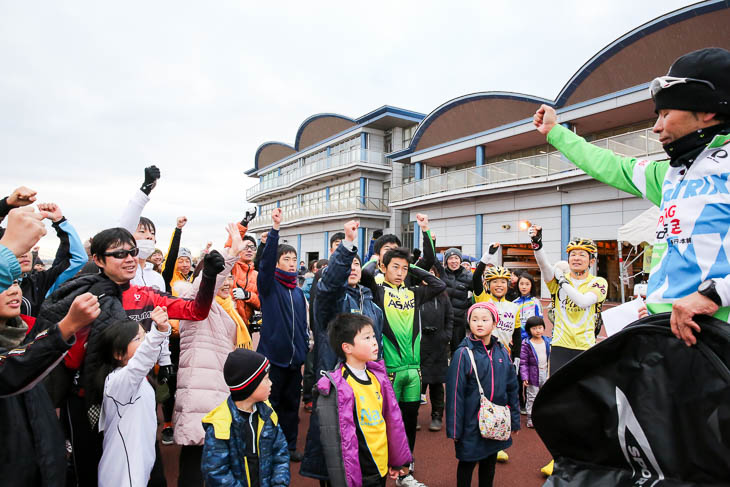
top-left (390, 129), bottom-right (662, 204)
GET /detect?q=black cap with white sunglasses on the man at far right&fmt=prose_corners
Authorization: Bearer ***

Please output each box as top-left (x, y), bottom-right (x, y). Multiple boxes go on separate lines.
top-left (652, 47), bottom-right (730, 114)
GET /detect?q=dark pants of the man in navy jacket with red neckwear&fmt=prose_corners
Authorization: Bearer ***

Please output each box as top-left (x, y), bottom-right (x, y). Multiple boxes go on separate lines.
top-left (269, 364), bottom-right (302, 450)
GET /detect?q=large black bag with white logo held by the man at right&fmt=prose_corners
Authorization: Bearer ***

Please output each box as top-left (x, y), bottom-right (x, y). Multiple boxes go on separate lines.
top-left (532, 313), bottom-right (730, 487)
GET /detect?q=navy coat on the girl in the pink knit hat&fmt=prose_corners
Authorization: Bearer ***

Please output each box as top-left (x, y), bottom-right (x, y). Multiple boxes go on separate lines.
top-left (445, 334), bottom-right (520, 462)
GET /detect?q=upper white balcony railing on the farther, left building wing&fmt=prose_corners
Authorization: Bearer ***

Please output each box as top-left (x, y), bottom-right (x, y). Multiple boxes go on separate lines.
top-left (246, 148), bottom-right (391, 200)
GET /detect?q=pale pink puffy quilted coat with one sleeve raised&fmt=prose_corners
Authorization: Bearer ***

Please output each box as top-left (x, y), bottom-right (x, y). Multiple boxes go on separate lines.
top-left (173, 256), bottom-right (238, 445)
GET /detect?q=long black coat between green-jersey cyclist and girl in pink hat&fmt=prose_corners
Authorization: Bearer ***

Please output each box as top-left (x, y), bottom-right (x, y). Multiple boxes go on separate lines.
top-left (421, 293), bottom-right (454, 384)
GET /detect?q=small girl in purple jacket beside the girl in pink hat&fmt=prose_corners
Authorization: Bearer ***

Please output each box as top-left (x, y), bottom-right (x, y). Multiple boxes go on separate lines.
top-left (520, 316), bottom-right (550, 428)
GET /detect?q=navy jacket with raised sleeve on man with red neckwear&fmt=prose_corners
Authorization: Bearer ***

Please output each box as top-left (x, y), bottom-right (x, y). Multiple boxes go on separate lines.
top-left (256, 229), bottom-right (309, 367)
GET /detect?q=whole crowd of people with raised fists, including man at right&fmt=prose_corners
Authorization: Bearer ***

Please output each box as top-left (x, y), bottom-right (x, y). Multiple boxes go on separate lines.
top-left (0, 48), bottom-right (730, 487)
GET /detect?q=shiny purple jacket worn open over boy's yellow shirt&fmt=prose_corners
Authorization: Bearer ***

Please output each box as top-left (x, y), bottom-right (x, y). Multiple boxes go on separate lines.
top-left (317, 361), bottom-right (413, 487)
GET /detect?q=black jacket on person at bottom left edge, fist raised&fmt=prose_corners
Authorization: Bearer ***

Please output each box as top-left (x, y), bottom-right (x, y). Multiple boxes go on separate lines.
top-left (0, 323), bottom-right (74, 487)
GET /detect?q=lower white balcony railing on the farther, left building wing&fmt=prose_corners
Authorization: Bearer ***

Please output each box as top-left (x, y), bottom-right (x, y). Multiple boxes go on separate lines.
top-left (249, 196), bottom-right (390, 229)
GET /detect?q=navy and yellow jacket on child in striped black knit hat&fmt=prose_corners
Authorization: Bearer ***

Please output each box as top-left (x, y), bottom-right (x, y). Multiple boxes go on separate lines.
top-left (201, 396), bottom-right (291, 487)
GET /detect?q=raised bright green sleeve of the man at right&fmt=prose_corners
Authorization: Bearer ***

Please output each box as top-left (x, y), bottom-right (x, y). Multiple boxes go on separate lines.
top-left (547, 125), bottom-right (669, 206)
